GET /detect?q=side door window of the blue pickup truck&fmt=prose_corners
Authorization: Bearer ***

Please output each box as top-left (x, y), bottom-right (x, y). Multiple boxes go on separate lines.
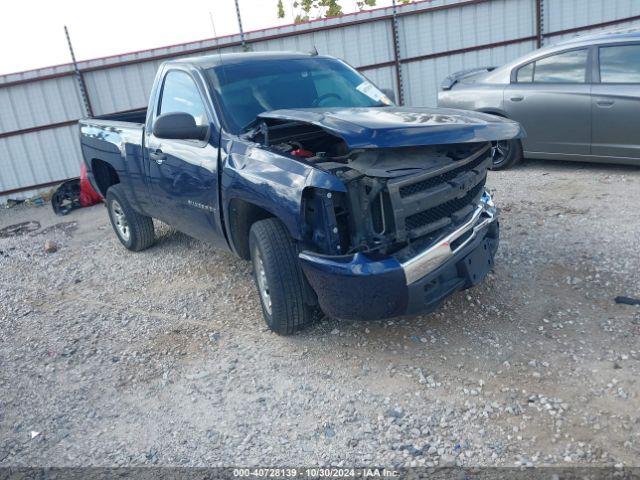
top-left (158, 70), bottom-right (208, 126)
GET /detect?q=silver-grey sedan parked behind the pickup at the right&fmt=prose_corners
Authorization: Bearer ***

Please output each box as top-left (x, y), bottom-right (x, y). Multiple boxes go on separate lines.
top-left (438, 32), bottom-right (640, 170)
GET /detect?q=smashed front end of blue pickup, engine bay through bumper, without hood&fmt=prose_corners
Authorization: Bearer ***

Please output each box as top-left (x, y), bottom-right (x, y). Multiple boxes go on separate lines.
top-left (245, 109), bottom-right (517, 319)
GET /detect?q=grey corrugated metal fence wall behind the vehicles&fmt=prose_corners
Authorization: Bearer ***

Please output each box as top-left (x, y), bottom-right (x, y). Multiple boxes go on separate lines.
top-left (0, 0), bottom-right (640, 201)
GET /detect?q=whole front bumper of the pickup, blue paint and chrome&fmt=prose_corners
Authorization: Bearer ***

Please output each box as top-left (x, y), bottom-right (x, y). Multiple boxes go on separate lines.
top-left (300, 192), bottom-right (499, 320)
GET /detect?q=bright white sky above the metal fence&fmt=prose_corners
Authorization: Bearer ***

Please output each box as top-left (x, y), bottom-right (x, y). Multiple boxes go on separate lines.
top-left (0, 0), bottom-right (398, 75)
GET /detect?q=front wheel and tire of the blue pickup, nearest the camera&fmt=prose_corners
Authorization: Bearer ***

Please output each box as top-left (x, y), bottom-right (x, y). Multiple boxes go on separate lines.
top-left (249, 218), bottom-right (316, 335)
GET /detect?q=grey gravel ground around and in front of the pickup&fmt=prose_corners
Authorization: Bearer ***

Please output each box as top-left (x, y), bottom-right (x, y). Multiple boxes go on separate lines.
top-left (0, 161), bottom-right (640, 467)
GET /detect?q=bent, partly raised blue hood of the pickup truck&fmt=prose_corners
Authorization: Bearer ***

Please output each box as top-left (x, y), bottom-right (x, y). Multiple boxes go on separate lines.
top-left (259, 107), bottom-right (525, 149)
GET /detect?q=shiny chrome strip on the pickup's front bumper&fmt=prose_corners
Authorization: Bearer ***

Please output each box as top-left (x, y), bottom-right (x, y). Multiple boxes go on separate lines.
top-left (400, 191), bottom-right (498, 285)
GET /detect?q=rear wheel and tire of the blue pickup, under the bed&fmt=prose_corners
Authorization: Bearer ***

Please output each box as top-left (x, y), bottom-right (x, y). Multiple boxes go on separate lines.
top-left (106, 184), bottom-right (155, 252)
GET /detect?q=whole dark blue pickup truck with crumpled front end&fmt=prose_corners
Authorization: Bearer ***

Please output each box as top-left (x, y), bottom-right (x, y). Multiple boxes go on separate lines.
top-left (80, 53), bottom-right (523, 334)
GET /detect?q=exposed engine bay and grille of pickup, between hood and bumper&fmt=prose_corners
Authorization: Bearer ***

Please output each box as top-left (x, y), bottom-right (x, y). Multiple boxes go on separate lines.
top-left (251, 120), bottom-right (491, 258)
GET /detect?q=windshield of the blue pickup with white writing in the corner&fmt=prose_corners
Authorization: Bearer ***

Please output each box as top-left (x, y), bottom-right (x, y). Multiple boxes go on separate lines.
top-left (206, 57), bottom-right (391, 133)
